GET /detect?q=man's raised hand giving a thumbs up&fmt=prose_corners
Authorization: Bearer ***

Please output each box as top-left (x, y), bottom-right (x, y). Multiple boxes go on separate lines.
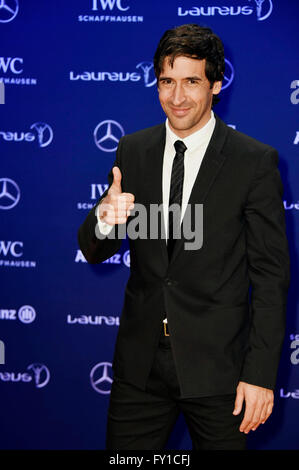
top-left (99, 166), bottom-right (135, 225)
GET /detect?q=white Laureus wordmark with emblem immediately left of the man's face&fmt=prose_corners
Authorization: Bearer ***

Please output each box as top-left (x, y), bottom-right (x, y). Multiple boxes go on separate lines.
top-left (70, 61), bottom-right (157, 88)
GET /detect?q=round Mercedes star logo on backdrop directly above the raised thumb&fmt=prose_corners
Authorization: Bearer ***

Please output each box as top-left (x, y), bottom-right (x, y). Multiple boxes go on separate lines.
top-left (93, 119), bottom-right (125, 152)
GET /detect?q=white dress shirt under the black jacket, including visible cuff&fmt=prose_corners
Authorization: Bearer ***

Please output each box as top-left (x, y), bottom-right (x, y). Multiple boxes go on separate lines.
top-left (97, 111), bottom-right (216, 239)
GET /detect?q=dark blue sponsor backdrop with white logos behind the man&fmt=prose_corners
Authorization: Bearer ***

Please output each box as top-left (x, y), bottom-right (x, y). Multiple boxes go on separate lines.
top-left (0, 0), bottom-right (299, 449)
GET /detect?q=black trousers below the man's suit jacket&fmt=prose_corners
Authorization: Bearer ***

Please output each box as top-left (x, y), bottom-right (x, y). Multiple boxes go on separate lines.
top-left (106, 329), bottom-right (246, 450)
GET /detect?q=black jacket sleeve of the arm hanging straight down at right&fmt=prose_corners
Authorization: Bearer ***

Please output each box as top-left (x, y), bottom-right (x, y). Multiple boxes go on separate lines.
top-left (240, 149), bottom-right (289, 389)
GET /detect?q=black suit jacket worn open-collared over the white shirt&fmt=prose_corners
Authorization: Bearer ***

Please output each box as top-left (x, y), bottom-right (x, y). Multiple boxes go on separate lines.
top-left (78, 116), bottom-right (289, 398)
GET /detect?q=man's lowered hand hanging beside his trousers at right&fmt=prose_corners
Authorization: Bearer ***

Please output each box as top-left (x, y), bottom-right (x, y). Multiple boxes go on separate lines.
top-left (233, 382), bottom-right (274, 434)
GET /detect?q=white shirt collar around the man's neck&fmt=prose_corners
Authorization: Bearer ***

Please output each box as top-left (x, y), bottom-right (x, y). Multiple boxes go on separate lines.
top-left (165, 110), bottom-right (216, 152)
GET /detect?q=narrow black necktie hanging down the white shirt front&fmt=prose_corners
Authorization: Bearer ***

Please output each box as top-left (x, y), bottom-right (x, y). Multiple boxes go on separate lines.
top-left (167, 140), bottom-right (187, 259)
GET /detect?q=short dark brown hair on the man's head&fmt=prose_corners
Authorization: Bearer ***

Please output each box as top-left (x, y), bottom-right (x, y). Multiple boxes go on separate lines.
top-left (154, 23), bottom-right (225, 105)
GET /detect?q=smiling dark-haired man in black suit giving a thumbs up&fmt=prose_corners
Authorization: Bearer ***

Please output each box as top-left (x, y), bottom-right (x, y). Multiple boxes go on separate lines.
top-left (79, 24), bottom-right (289, 450)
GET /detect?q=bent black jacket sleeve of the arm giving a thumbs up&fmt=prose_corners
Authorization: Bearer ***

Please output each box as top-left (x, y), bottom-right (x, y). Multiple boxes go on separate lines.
top-left (78, 138), bottom-right (126, 264)
